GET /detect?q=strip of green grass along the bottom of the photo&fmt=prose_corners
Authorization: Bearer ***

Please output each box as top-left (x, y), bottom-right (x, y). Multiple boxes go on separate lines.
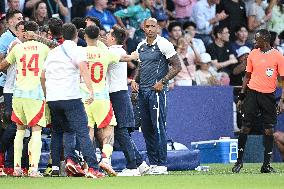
top-left (0, 163), bottom-right (284, 189)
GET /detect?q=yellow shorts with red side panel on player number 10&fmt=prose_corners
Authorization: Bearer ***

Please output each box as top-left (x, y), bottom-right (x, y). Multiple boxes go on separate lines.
top-left (84, 100), bottom-right (117, 128)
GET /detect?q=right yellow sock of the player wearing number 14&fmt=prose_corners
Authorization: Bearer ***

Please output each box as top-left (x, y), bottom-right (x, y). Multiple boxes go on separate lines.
top-left (29, 131), bottom-right (42, 169)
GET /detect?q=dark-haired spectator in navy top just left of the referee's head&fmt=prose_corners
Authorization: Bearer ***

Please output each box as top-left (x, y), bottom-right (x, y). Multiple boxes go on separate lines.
top-left (230, 25), bottom-right (252, 57)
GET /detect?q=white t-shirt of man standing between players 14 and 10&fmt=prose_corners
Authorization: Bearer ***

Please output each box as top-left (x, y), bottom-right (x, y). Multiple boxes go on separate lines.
top-left (44, 40), bottom-right (87, 101)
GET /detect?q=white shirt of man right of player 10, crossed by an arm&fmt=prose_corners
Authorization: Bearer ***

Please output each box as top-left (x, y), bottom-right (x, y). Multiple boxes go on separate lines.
top-left (107, 45), bottom-right (128, 93)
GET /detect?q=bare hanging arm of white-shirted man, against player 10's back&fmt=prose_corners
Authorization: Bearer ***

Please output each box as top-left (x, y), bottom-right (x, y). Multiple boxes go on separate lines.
top-left (79, 62), bottom-right (94, 104)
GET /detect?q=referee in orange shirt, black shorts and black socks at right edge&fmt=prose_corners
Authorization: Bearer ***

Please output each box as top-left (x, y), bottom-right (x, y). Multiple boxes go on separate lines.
top-left (232, 29), bottom-right (284, 173)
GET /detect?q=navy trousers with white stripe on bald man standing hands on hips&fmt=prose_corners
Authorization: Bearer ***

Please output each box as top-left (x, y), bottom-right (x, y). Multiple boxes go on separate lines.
top-left (138, 88), bottom-right (167, 165)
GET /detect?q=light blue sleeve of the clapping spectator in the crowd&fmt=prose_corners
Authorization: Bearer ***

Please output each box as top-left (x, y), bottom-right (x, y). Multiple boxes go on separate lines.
top-left (192, 4), bottom-right (210, 30)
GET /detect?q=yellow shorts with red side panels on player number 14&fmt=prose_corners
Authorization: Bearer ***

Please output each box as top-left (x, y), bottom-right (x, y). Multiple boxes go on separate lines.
top-left (11, 97), bottom-right (46, 127)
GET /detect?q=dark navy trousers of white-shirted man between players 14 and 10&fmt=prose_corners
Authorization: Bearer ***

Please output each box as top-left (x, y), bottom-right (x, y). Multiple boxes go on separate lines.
top-left (48, 99), bottom-right (98, 169)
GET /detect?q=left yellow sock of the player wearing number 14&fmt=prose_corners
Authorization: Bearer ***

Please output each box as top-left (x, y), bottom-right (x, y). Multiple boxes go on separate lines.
top-left (14, 130), bottom-right (26, 168)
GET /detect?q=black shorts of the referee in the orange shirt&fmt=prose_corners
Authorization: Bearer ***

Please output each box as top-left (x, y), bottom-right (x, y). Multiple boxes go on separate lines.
top-left (242, 89), bottom-right (277, 126)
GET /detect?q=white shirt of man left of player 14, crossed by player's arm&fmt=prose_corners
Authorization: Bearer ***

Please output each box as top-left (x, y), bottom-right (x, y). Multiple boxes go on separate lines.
top-left (3, 38), bottom-right (22, 93)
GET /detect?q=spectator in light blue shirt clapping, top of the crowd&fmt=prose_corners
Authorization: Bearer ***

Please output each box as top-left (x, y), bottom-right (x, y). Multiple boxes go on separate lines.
top-left (192, 0), bottom-right (228, 47)
